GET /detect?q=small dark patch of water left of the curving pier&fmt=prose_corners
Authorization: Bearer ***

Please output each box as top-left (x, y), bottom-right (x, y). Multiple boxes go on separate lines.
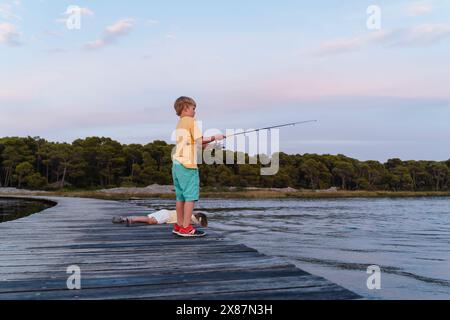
top-left (0, 198), bottom-right (51, 223)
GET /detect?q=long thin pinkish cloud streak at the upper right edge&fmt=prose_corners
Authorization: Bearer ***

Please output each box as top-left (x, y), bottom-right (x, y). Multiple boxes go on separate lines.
top-left (314, 24), bottom-right (450, 57)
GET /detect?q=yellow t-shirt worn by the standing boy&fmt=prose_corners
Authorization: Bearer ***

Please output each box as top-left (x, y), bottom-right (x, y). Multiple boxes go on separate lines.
top-left (172, 117), bottom-right (203, 169)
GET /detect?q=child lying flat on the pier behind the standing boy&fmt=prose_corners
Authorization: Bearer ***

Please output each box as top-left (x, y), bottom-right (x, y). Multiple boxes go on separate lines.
top-left (112, 210), bottom-right (208, 228)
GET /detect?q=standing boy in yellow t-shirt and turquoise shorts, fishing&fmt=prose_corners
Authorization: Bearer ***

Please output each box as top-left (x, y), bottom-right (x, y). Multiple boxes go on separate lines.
top-left (172, 97), bottom-right (225, 237)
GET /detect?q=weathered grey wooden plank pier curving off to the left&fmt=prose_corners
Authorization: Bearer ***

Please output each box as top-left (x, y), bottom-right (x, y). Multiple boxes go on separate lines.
top-left (0, 197), bottom-right (360, 300)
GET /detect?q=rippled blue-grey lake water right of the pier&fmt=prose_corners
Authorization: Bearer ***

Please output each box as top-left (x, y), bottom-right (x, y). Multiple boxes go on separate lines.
top-left (125, 198), bottom-right (450, 299)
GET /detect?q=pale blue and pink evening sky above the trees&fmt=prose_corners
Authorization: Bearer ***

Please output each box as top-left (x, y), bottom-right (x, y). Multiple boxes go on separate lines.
top-left (0, 0), bottom-right (450, 161)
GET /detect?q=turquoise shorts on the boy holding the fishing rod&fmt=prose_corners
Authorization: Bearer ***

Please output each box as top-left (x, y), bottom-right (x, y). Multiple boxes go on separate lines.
top-left (172, 160), bottom-right (200, 202)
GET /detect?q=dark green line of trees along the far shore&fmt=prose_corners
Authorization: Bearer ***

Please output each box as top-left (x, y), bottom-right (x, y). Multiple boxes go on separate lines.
top-left (0, 137), bottom-right (450, 191)
